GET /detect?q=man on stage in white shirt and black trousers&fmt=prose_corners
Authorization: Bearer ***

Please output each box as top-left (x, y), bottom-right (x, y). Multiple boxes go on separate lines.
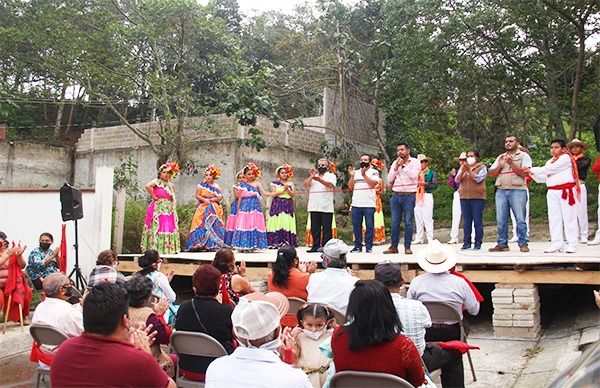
top-left (304, 158), bottom-right (337, 252)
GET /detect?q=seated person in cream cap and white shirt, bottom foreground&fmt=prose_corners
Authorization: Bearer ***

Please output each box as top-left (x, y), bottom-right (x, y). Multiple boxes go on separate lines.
top-left (206, 298), bottom-right (312, 388)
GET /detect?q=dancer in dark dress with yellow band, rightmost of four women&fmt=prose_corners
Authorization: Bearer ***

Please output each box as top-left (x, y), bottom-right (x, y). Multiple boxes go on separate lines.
top-left (267, 163), bottom-right (297, 249)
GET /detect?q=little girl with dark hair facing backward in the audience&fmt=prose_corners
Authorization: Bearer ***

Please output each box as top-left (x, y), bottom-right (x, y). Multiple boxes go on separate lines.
top-left (293, 303), bottom-right (334, 388)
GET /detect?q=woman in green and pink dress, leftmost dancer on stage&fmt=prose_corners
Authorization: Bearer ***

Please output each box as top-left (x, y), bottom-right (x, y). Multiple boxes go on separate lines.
top-left (140, 162), bottom-right (179, 254)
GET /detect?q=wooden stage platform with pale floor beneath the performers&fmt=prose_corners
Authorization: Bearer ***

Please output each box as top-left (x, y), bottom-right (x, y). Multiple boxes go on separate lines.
top-left (119, 242), bottom-right (600, 285)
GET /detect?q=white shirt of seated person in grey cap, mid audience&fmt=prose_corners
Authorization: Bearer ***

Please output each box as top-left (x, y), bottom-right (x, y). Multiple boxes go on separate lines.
top-left (306, 267), bottom-right (359, 314)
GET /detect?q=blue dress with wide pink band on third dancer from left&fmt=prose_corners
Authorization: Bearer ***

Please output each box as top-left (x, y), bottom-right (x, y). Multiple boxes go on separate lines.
top-left (231, 182), bottom-right (267, 250)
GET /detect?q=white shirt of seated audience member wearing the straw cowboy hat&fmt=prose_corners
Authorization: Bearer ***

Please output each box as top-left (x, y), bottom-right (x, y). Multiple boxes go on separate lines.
top-left (406, 272), bottom-right (479, 324)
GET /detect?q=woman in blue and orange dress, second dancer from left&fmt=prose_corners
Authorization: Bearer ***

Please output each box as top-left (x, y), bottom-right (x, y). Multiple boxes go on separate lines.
top-left (185, 164), bottom-right (225, 251)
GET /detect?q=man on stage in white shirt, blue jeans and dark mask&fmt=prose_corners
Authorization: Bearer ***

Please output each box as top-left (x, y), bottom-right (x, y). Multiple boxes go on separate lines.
top-left (348, 154), bottom-right (379, 253)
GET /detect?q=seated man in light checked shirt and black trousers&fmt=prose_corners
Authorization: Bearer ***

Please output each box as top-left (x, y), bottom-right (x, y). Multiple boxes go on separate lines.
top-left (375, 261), bottom-right (465, 387)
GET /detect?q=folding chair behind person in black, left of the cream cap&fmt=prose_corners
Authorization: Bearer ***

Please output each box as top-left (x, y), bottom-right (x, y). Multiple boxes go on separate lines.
top-left (171, 330), bottom-right (227, 388)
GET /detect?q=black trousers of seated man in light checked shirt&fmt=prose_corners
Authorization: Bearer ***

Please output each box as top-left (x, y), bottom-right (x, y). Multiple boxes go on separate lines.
top-left (423, 343), bottom-right (465, 388)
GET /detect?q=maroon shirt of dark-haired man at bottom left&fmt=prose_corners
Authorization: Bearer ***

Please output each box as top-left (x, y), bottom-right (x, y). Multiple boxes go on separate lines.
top-left (50, 333), bottom-right (169, 388)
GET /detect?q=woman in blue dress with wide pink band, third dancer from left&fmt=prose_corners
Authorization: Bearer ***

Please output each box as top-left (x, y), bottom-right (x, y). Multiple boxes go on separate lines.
top-left (231, 163), bottom-right (272, 252)
